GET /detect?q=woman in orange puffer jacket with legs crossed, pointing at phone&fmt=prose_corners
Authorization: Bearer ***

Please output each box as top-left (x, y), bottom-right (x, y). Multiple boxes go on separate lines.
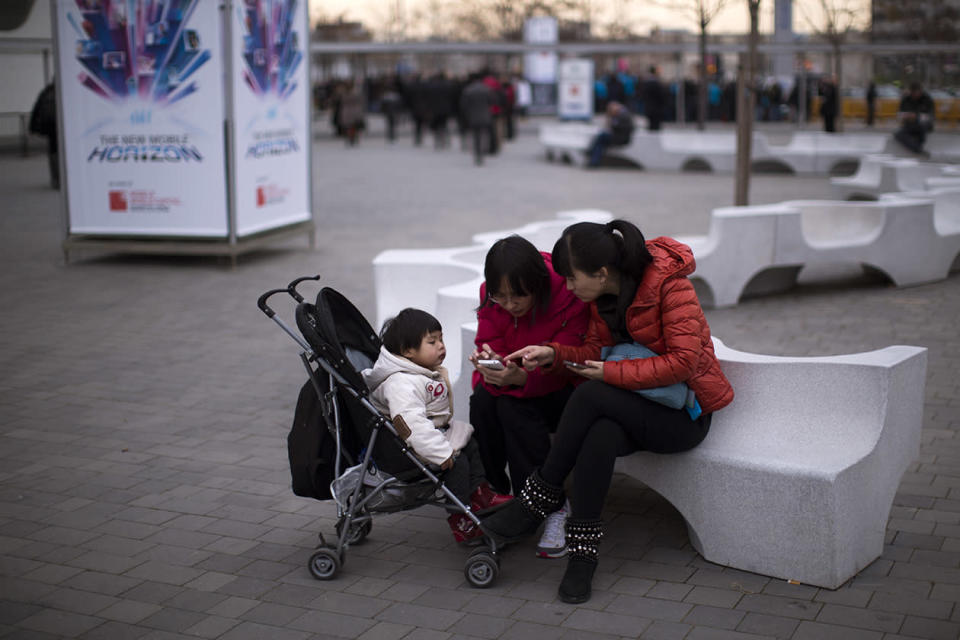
top-left (483, 220), bottom-right (733, 603)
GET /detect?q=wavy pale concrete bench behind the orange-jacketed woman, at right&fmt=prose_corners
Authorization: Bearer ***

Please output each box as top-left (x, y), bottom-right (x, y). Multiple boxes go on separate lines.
top-left (677, 198), bottom-right (958, 307)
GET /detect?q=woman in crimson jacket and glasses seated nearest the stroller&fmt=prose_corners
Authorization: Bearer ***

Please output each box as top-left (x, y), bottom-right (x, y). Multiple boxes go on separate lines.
top-left (469, 236), bottom-right (590, 558)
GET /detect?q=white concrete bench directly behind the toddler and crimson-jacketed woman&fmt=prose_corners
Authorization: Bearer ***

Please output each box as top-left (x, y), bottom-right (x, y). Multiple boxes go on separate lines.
top-left (373, 209), bottom-right (612, 379)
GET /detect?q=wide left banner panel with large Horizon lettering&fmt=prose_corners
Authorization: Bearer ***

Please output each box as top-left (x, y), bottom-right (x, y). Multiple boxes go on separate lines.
top-left (55, 0), bottom-right (228, 237)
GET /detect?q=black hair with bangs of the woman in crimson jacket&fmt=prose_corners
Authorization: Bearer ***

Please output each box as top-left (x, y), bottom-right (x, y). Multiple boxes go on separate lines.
top-left (480, 235), bottom-right (550, 316)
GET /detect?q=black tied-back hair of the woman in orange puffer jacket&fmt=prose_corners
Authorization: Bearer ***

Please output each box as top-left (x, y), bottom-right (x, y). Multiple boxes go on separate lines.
top-left (553, 220), bottom-right (653, 282)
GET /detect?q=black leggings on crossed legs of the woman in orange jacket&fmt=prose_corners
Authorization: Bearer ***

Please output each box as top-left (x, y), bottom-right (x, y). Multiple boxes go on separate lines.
top-left (540, 380), bottom-right (710, 520)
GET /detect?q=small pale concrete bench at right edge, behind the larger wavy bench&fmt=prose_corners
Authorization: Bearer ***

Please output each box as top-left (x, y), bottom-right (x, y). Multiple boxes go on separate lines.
top-left (830, 155), bottom-right (949, 200)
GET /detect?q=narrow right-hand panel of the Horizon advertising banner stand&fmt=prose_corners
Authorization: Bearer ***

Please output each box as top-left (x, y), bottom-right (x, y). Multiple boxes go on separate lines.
top-left (231, 0), bottom-right (310, 236)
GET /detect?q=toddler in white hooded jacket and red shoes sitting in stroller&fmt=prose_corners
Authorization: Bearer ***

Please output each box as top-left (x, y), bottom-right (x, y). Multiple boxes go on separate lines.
top-left (362, 308), bottom-right (513, 543)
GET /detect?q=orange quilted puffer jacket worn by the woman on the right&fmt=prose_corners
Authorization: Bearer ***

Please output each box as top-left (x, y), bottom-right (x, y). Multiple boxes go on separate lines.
top-left (549, 237), bottom-right (733, 413)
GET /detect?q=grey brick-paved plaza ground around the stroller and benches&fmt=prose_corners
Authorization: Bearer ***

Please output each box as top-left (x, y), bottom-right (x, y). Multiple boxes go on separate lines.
top-left (0, 121), bottom-right (960, 640)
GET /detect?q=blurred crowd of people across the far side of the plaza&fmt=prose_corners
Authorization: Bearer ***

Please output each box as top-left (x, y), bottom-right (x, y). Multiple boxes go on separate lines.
top-left (314, 65), bottom-right (933, 160)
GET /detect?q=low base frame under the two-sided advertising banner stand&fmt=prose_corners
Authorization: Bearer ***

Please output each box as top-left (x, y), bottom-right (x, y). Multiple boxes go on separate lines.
top-left (63, 220), bottom-right (316, 268)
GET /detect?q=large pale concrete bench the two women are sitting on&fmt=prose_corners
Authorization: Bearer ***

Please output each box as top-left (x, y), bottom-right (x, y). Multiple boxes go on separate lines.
top-left (453, 322), bottom-right (926, 589)
